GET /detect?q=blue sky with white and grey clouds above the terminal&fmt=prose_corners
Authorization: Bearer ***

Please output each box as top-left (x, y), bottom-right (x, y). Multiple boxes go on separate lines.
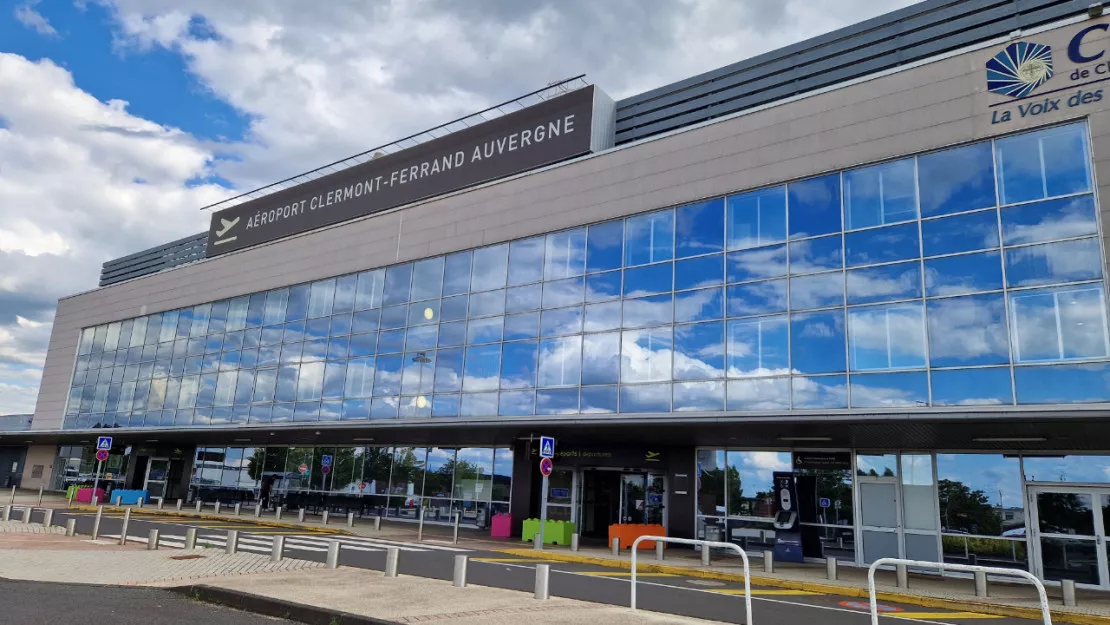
top-left (0, 0), bottom-right (912, 414)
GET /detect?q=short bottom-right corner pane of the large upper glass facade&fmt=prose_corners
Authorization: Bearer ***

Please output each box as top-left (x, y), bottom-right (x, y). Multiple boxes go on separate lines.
top-left (1013, 363), bottom-right (1110, 406)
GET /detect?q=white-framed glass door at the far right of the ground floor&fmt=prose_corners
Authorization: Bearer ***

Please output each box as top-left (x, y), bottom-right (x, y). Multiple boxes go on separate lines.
top-left (1029, 486), bottom-right (1110, 588)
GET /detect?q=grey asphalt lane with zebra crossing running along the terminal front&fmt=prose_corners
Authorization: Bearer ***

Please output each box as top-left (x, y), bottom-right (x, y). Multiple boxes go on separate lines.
top-left (19, 511), bottom-right (1036, 625)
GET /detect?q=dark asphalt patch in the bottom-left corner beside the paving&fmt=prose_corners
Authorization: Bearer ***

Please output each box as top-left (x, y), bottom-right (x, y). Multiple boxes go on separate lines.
top-left (0, 579), bottom-right (293, 625)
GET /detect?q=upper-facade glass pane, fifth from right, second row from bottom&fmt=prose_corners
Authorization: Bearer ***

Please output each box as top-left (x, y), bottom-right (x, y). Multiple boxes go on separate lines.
top-left (727, 315), bottom-right (790, 377)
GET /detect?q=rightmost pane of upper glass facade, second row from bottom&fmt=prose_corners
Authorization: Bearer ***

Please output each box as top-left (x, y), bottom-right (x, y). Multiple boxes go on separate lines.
top-left (1010, 285), bottom-right (1110, 362)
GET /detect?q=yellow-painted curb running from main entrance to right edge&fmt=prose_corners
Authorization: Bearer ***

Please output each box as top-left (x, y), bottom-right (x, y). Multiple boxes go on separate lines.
top-left (498, 548), bottom-right (1110, 625)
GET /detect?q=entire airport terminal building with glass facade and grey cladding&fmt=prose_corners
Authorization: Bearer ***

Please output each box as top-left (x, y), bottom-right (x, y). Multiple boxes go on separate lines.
top-left (10, 0), bottom-right (1110, 589)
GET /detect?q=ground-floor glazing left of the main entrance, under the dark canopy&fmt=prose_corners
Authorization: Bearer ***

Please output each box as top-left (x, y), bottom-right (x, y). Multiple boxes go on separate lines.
top-left (189, 446), bottom-right (513, 527)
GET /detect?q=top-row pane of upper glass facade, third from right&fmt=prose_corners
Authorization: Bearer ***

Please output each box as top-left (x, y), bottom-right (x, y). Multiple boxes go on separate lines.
top-left (844, 159), bottom-right (917, 230)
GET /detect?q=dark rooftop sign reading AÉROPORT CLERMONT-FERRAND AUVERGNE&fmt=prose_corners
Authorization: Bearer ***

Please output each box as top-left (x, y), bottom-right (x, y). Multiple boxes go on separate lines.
top-left (206, 85), bottom-right (612, 258)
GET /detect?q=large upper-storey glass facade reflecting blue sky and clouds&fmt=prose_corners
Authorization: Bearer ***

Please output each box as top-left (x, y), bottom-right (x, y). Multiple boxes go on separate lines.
top-left (64, 123), bottom-right (1110, 429)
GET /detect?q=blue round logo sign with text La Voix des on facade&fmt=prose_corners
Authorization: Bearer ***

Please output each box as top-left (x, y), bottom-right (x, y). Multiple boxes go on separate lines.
top-left (986, 21), bottom-right (1110, 125)
